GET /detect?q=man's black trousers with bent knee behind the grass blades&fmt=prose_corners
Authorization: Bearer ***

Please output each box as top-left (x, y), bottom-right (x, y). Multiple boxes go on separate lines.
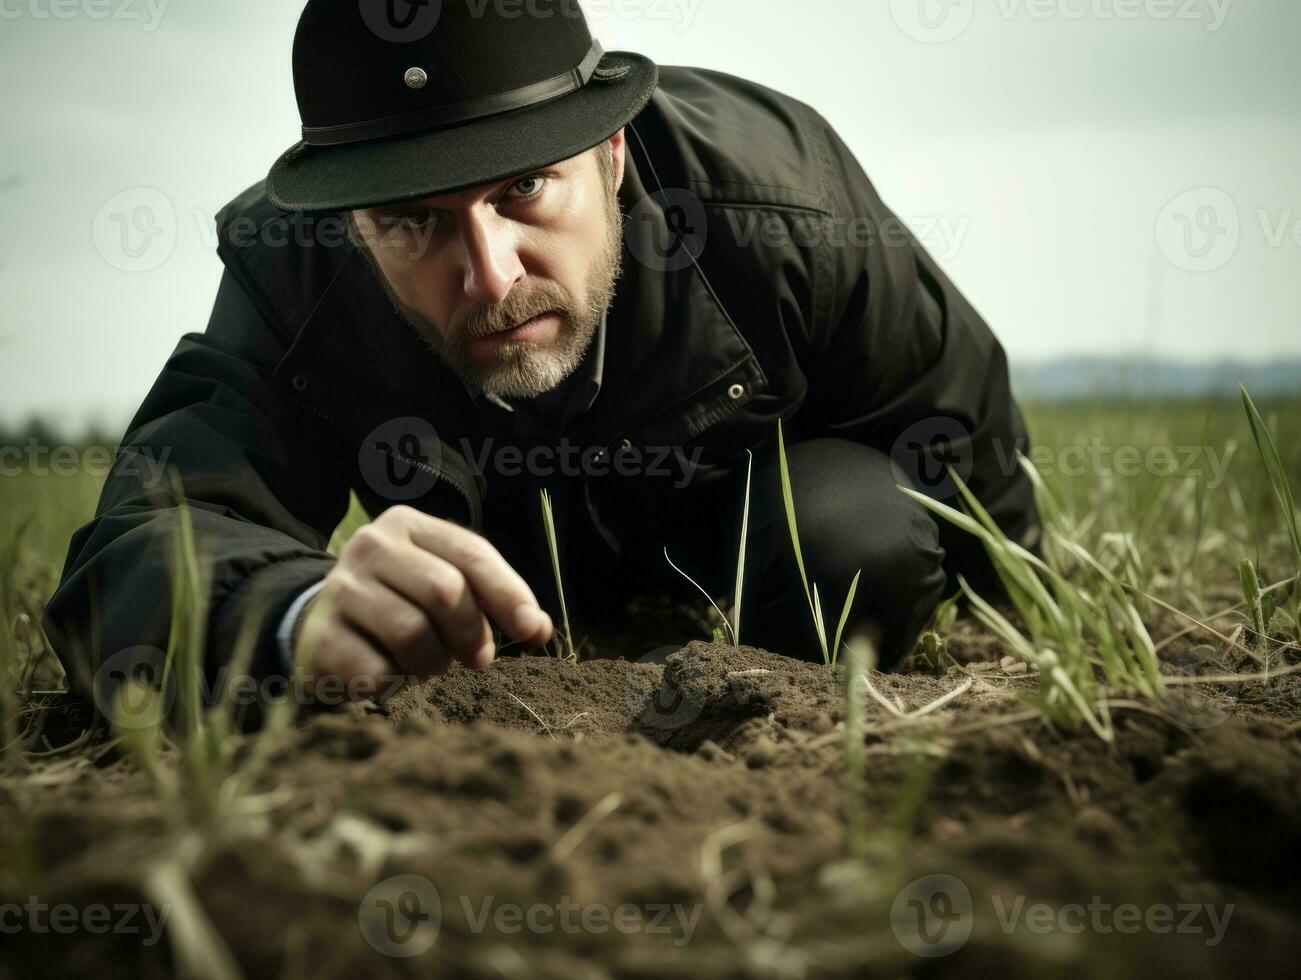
top-left (567, 439), bottom-right (947, 666)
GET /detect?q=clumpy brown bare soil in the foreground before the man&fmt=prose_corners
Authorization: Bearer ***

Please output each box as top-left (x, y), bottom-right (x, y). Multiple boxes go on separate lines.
top-left (0, 622), bottom-right (1301, 980)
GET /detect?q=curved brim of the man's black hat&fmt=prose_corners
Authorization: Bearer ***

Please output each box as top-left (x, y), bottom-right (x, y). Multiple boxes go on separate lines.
top-left (267, 51), bottom-right (658, 211)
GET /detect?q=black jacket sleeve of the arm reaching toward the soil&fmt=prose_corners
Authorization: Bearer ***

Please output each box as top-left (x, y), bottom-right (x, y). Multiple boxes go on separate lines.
top-left (46, 271), bottom-right (355, 696)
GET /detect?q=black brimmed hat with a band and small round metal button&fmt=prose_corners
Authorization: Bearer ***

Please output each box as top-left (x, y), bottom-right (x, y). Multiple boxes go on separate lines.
top-left (267, 0), bottom-right (658, 211)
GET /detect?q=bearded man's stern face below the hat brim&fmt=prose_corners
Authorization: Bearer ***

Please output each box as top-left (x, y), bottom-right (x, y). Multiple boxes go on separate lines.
top-left (351, 130), bottom-right (624, 398)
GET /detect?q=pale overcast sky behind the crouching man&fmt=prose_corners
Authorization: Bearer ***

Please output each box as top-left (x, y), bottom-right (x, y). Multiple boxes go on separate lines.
top-left (0, 0), bottom-right (1301, 429)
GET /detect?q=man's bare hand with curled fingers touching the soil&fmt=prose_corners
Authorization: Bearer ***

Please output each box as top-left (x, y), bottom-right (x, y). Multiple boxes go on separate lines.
top-left (294, 506), bottom-right (553, 699)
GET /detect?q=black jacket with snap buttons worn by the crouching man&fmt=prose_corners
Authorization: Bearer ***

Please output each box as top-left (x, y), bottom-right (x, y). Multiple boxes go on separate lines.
top-left (46, 68), bottom-right (1037, 691)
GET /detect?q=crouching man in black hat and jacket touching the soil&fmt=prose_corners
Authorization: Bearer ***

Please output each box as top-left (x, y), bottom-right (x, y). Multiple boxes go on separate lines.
top-left (47, 0), bottom-right (1037, 696)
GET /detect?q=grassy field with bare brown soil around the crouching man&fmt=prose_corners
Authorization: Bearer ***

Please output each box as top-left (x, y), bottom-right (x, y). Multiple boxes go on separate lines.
top-left (0, 398), bottom-right (1301, 977)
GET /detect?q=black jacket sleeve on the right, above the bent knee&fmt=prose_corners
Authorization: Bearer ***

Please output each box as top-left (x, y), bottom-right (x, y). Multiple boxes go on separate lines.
top-left (809, 120), bottom-right (1039, 582)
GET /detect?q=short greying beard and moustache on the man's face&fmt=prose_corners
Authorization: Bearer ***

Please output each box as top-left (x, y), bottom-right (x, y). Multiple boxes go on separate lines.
top-left (362, 182), bottom-right (623, 398)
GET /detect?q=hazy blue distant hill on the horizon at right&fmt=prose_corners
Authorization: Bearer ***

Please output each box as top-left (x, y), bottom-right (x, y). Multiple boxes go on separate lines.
top-left (1012, 357), bottom-right (1301, 401)
